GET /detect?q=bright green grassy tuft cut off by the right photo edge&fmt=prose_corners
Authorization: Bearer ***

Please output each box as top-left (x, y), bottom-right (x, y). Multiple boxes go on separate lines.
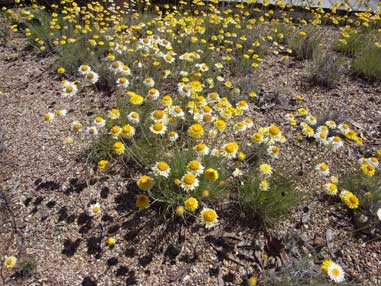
top-left (352, 43), bottom-right (381, 80)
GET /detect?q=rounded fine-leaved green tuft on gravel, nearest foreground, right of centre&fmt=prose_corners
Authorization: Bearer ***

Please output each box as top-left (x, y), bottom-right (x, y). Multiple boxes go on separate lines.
top-left (238, 171), bottom-right (300, 227)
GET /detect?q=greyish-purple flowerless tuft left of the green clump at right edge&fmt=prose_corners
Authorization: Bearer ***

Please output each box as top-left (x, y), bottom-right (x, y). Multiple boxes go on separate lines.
top-left (307, 52), bottom-right (344, 88)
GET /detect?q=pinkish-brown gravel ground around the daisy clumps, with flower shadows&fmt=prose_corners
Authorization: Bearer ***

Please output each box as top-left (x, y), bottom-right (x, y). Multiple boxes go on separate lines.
top-left (0, 38), bottom-right (381, 286)
